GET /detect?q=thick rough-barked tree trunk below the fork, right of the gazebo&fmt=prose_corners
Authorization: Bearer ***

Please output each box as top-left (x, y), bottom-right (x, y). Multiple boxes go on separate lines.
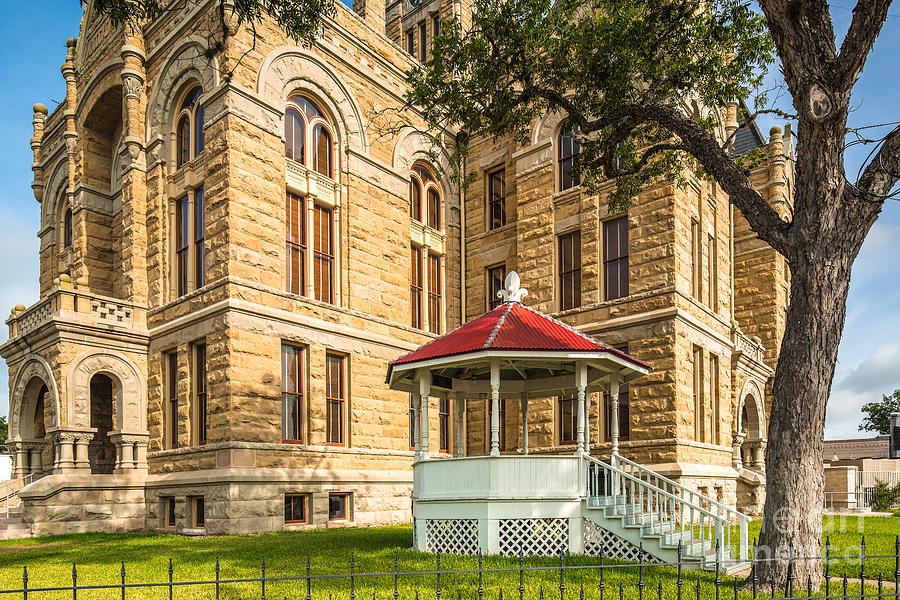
top-left (757, 220), bottom-right (859, 586)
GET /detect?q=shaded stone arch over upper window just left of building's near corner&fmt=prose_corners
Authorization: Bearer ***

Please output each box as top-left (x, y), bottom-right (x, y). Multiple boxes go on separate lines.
top-left (146, 35), bottom-right (219, 164)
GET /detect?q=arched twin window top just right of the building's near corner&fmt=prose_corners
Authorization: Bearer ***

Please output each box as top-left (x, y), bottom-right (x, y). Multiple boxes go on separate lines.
top-left (284, 96), bottom-right (334, 177)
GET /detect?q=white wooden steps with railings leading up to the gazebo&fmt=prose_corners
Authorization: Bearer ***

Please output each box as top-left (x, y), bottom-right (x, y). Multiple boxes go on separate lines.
top-left (582, 455), bottom-right (751, 574)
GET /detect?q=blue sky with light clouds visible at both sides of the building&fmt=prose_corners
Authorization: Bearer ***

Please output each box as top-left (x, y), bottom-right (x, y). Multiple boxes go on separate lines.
top-left (0, 0), bottom-right (900, 438)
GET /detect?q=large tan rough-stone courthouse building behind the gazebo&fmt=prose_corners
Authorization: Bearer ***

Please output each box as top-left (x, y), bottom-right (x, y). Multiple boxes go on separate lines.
top-left (0, 0), bottom-right (793, 534)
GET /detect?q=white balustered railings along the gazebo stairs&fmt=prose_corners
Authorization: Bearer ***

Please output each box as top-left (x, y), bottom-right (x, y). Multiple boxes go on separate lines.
top-left (585, 455), bottom-right (750, 560)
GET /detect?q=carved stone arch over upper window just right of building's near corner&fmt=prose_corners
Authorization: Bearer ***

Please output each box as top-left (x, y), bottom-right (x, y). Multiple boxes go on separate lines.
top-left (256, 46), bottom-right (369, 155)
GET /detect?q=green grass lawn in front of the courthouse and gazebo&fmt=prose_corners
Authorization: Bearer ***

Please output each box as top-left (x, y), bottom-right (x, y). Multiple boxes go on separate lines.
top-left (0, 517), bottom-right (900, 600)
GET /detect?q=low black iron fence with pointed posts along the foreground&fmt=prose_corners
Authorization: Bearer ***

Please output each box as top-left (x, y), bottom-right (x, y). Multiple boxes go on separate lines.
top-left (0, 535), bottom-right (900, 600)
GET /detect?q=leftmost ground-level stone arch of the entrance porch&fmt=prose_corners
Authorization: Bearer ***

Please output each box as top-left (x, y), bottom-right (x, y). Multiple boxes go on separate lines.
top-left (9, 355), bottom-right (60, 440)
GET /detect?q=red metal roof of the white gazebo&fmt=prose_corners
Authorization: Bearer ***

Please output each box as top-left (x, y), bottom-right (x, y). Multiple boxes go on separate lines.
top-left (390, 302), bottom-right (649, 369)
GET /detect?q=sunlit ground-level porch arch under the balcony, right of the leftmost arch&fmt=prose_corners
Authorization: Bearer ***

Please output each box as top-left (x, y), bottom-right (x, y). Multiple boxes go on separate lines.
top-left (66, 350), bottom-right (147, 433)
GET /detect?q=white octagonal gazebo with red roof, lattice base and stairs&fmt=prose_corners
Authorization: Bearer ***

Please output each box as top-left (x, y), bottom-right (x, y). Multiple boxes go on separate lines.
top-left (387, 272), bottom-right (746, 567)
